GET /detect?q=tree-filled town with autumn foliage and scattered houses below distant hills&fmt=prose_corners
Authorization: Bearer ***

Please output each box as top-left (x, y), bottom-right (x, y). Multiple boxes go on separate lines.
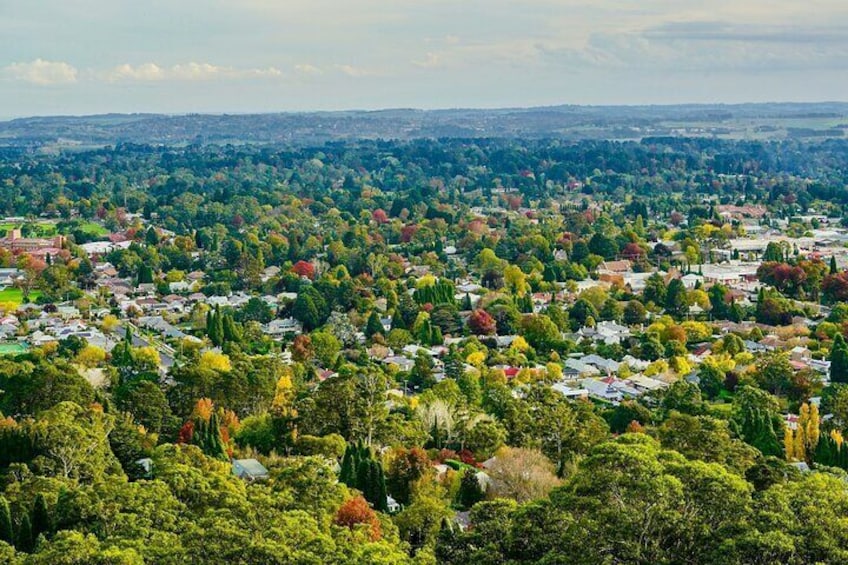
top-left (0, 137), bottom-right (848, 565)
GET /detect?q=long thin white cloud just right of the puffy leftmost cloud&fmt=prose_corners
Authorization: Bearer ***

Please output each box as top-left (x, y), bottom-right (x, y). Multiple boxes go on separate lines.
top-left (103, 62), bottom-right (283, 82)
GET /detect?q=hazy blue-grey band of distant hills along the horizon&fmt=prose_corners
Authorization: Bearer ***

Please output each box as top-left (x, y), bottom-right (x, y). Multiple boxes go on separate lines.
top-left (0, 102), bottom-right (848, 149)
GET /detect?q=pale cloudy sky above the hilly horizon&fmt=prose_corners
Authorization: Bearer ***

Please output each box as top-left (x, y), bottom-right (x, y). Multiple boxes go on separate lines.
top-left (0, 0), bottom-right (848, 118)
